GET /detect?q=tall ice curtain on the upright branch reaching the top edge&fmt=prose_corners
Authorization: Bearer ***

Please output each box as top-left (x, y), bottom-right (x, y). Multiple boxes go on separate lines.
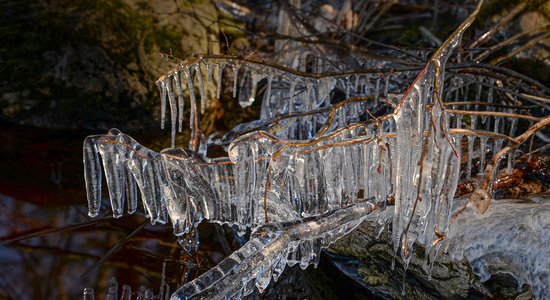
top-left (392, 1), bottom-right (482, 267)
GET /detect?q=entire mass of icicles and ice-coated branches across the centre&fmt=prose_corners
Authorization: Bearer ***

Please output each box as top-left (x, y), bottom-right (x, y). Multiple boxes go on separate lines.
top-left (84, 1), bottom-right (549, 299)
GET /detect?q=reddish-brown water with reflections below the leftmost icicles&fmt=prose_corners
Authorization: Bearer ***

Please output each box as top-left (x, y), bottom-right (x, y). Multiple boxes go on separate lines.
top-left (0, 189), bottom-right (196, 299)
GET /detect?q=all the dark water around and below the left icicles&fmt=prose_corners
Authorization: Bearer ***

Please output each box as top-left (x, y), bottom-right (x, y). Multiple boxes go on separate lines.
top-left (0, 125), bottom-right (371, 299)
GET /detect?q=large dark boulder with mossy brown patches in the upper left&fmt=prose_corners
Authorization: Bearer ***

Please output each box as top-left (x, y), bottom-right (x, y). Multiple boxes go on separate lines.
top-left (0, 0), bottom-right (219, 130)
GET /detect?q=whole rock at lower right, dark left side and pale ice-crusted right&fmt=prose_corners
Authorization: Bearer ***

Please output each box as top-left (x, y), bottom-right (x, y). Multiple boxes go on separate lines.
top-left (327, 200), bottom-right (550, 299)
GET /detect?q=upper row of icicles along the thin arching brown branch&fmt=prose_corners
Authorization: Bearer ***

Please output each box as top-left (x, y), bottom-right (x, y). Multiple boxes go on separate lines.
top-left (157, 51), bottom-right (418, 145)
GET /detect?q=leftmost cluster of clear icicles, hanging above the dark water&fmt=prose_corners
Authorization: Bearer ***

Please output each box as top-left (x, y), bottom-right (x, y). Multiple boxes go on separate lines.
top-left (84, 129), bottom-right (167, 223)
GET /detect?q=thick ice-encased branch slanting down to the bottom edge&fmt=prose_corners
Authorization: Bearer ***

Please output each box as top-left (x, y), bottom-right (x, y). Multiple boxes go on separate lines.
top-left (170, 202), bottom-right (375, 300)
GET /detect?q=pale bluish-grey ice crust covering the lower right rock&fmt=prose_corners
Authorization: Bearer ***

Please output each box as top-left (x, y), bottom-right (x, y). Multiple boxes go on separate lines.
top-left (448, 200), bottom-right (550, 299)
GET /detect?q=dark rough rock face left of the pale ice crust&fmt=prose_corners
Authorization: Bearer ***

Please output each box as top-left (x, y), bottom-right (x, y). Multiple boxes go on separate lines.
top-left (328, 220), bottom-right (475, 299)
